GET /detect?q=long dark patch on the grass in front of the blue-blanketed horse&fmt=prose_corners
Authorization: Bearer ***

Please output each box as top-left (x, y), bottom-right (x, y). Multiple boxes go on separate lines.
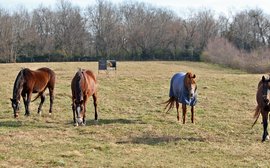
top-left (116, 135), bottom-right (205, 145)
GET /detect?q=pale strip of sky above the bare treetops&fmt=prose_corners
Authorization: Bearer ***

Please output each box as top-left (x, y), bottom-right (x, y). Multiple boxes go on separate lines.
top-left (0, 0), bottom-right (270, 15)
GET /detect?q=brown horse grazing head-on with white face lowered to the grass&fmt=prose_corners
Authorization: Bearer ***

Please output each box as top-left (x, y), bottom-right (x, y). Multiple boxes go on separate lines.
top-left (71, 69), bottom-right (98, 126)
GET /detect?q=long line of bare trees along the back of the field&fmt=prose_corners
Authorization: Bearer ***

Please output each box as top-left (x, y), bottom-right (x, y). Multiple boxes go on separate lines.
top-left (0, 0), bottom-right (270, 62)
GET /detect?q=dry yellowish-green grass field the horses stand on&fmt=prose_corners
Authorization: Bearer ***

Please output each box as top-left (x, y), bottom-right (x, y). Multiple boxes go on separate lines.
top-left (0, 62), bottom-right (270, 167)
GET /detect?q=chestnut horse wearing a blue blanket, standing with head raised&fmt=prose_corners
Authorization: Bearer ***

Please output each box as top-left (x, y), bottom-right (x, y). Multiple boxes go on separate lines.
top-left (164, 72), bottom-right (197, 124)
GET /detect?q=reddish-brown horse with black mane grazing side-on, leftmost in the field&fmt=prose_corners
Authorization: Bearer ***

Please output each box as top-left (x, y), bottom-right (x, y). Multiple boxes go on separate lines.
top-left (10, 68), bottom-right (55, 118)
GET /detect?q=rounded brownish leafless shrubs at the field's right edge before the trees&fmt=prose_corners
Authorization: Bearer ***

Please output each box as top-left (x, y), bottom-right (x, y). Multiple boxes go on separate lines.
top-left (202, 37), bottom-right (270, 73)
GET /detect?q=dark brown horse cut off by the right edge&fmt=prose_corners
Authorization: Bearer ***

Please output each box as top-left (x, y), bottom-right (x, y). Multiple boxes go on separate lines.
top-left (252, 76), bottom-right (270, 142)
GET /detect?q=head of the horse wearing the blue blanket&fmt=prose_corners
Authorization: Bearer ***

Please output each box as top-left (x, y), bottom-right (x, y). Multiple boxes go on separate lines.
top-left (185, 72), bottom-right (197, 98)
